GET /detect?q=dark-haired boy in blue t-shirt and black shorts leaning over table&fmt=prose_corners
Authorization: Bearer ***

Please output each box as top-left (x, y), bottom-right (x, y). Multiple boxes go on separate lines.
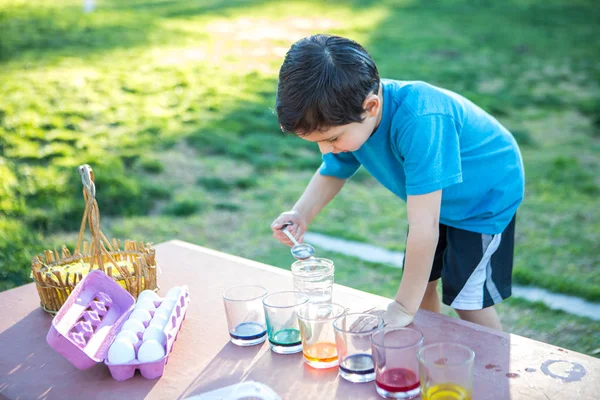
top-left (271, 35), bottom-right (524, 329)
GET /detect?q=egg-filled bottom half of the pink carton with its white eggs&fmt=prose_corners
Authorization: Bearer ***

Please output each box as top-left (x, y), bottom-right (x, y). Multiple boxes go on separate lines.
top-left (104, 286), bottom-right (190, 381)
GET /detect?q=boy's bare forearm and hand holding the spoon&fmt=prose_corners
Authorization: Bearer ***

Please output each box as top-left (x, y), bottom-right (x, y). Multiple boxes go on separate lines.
top-left (271, 170), bottom-right (346, 245)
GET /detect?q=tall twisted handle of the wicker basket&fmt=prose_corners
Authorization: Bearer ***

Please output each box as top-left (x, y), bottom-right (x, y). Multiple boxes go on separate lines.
top-left (75, 164), bottom-right (129, 290)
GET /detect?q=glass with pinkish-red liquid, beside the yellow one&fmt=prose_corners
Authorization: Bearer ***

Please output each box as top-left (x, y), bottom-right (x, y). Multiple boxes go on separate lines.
top-left (371, 327), bottom-right (423, 399)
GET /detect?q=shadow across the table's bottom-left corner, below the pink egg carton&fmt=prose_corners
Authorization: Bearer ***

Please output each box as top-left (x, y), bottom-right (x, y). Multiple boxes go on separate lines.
top-left (0, 308), bottom-right (158, 400)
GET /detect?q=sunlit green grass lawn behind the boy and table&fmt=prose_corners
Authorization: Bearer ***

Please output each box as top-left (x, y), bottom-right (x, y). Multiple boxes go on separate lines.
top-left (0, 0), bottom-right (600, 353)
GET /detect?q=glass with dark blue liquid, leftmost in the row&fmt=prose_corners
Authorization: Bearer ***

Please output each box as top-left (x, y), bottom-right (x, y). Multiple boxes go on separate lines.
top-left (223, 285), bottom-right (267, 346)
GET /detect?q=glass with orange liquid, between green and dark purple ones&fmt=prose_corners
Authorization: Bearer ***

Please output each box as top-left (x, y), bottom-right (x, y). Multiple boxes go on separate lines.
top-left (298, 303), bottom-right (346, 368)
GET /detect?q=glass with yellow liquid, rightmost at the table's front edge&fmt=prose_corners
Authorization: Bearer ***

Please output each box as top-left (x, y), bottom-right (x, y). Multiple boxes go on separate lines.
top-left (417, 343), bottom-right (475, 400)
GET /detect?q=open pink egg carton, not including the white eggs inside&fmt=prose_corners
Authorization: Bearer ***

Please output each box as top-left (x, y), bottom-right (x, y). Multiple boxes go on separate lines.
top-left (46, 270), bottom-right (190, 381)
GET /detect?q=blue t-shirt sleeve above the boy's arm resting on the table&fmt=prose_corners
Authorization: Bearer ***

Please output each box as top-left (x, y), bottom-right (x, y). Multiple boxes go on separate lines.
top-left (396, 114), bottom-right (462, 196)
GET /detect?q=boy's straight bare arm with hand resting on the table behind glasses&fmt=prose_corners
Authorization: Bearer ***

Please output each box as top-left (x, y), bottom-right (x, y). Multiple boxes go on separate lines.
top-left (385, 190), bottom-right (442, 326)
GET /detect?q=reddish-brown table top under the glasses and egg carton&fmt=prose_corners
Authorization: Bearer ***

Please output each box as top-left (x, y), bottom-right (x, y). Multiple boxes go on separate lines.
top-left (0, 241), bottom-right (600, 400)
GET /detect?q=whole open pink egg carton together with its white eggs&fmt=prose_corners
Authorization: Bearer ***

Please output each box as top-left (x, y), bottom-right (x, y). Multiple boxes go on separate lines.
top-left (46, 270), bottom-right (190, 381)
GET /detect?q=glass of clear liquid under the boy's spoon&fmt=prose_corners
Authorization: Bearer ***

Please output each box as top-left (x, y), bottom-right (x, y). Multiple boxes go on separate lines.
top-left (292, 257), bottom-right (334, 303)
